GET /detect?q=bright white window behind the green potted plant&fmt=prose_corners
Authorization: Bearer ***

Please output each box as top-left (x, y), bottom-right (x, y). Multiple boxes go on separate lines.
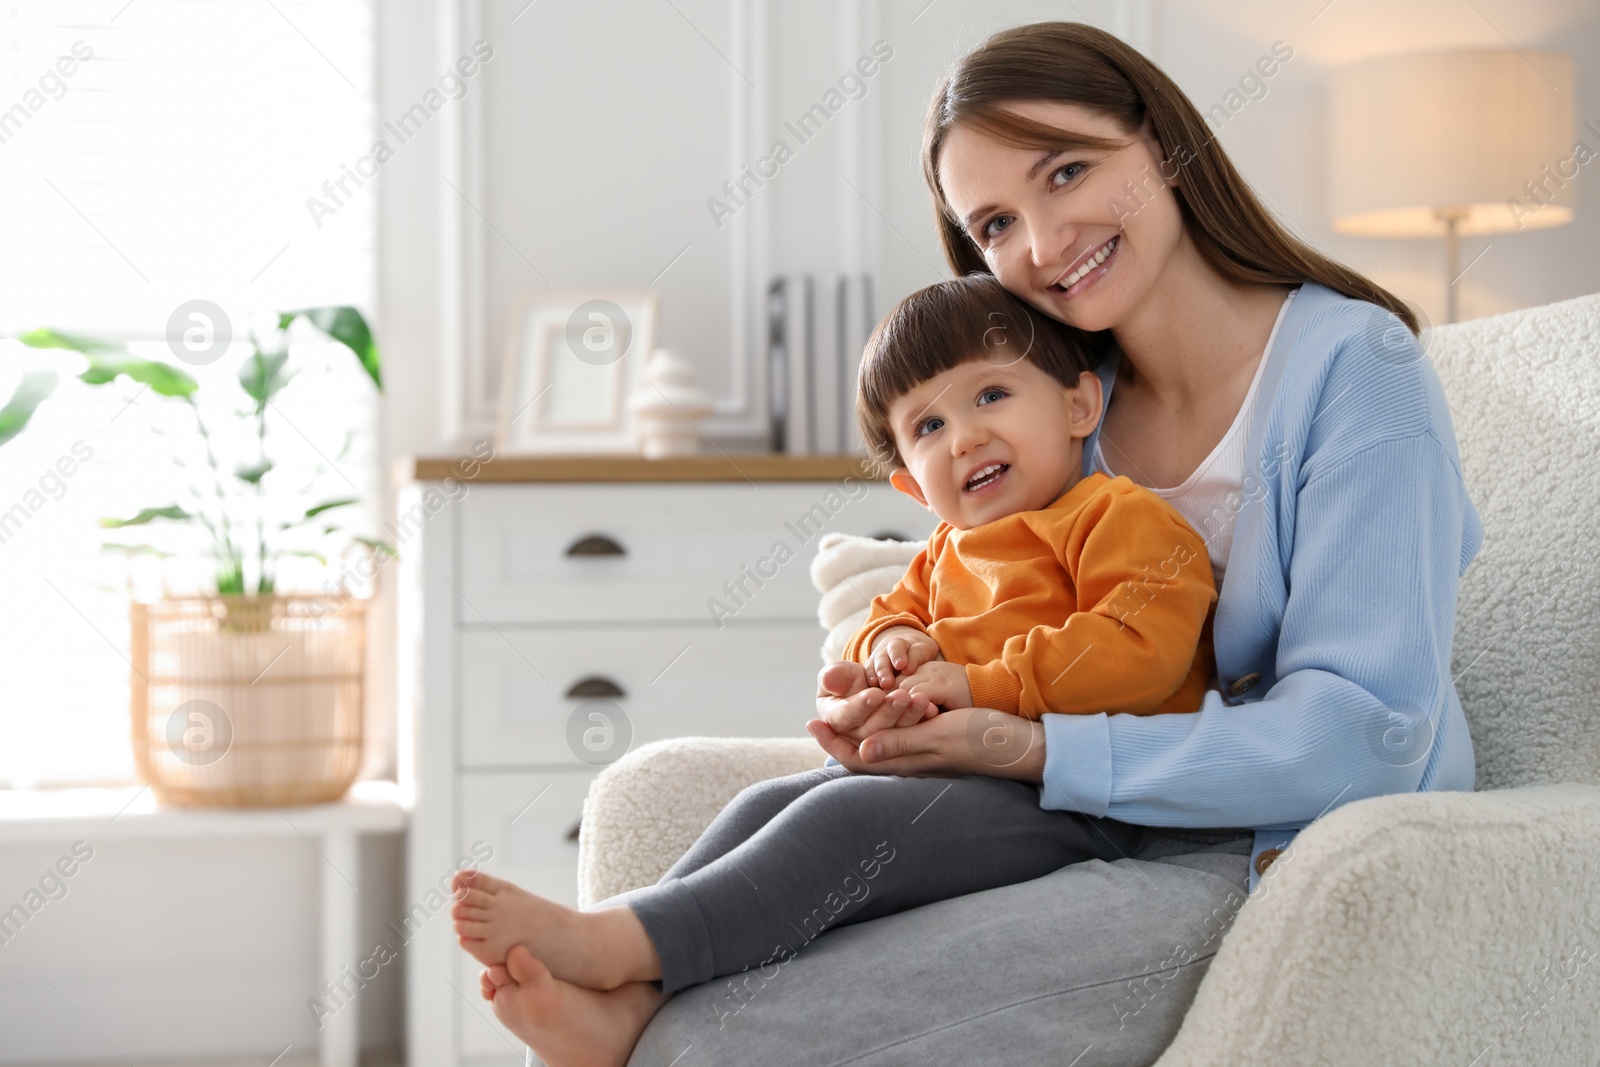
top-left (0, 0), bottom-right (378, 787)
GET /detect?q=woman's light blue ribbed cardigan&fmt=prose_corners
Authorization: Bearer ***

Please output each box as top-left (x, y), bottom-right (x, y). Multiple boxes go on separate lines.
top-left (1040, 283), bottom-right (1483, 889)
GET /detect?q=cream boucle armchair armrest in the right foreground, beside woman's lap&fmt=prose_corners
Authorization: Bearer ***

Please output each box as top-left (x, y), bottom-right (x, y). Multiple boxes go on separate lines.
top-left (1157, 784), bottom-right (1600, 1067)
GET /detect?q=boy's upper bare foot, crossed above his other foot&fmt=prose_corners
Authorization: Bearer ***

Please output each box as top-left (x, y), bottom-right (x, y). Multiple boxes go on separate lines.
top-left (450, 870), bottom-right (661, 989)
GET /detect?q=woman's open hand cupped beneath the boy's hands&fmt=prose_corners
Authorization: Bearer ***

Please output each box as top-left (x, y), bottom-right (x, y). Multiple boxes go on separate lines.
top-left (805, 699), bottom-right (1045, 784)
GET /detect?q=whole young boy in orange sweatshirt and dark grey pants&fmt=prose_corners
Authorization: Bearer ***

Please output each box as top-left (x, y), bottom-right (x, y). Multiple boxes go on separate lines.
top-left (451, 275), bottom-right (1216, 1003)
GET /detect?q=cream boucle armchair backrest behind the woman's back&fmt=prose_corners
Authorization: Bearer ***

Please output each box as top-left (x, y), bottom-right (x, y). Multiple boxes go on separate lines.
top-left (1426, 294), bottom-right (1600, 789)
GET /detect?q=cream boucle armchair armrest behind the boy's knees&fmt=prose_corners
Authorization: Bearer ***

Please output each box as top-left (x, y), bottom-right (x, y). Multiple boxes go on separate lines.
top-left (578, 737), bottom-right (827, 907)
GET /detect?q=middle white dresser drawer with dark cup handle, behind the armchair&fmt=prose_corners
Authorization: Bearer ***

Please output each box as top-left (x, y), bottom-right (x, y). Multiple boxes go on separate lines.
top-left (456, 622), bottom-right (824, 766)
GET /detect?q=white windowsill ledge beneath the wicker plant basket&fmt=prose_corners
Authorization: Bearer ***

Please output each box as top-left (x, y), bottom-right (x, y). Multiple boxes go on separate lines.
top-left (0, 782), bottom-right (410, 845)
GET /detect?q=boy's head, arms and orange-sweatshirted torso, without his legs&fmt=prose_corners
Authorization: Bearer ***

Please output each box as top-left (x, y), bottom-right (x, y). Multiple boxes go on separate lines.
top-left (825, 275), bottom-right (1216, 736)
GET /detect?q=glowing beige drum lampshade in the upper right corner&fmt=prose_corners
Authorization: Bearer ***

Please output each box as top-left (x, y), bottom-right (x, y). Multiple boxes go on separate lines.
top-left (1328, 50), bottom-right (1574, 237)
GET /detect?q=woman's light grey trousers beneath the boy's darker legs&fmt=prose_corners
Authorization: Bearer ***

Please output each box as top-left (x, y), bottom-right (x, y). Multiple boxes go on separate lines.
top-left (604, 767), bottom-right (1254, 1067)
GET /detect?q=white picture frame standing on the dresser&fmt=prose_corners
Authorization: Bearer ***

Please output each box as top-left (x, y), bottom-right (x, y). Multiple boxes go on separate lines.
top-left (496, 290), bottom-right (659, 454)
